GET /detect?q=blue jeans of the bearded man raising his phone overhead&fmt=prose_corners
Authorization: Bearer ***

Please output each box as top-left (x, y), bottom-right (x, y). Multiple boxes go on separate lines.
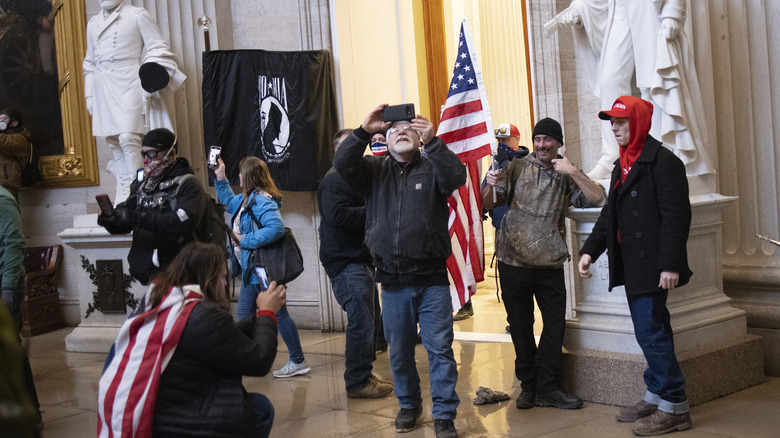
top-left (382, 284), bottom-right (460, 420)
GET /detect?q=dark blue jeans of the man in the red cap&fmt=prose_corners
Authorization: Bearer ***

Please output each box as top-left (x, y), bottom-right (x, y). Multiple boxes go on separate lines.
top-left (627, 289), bottom-right (688, 414)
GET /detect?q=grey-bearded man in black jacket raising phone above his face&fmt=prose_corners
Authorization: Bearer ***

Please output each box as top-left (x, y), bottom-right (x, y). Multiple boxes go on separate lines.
top-left (333, 105), bottom-right (466, 438)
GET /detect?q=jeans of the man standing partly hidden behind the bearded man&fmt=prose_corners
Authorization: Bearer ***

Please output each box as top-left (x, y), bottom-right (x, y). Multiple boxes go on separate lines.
top-left (330, 263), bottom-right (379, 391)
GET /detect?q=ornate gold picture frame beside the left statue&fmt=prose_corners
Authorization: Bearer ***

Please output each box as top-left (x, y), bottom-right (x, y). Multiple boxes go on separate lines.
top-left (36, 0), bottom-right (100, 187)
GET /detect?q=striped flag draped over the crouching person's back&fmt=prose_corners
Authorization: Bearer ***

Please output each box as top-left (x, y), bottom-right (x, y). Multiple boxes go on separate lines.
top-left (97, 285), bottom-right (203, 438)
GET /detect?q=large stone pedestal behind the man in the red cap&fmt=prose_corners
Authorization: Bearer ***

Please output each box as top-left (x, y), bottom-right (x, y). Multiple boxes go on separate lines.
top-left (564, 194), bottom-right (764, 405)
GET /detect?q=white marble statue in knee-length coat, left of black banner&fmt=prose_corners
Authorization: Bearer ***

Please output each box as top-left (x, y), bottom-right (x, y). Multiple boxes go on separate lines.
top-left (84, 0), bottom-right (186, 203)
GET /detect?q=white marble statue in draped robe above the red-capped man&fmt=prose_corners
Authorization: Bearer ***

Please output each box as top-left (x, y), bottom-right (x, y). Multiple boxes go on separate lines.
top-left (546, 0), bottom-right (715, 179)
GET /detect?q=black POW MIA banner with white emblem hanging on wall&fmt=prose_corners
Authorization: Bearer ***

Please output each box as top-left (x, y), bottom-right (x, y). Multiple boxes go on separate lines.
top-left (203, 50), bottom-right (338, 191)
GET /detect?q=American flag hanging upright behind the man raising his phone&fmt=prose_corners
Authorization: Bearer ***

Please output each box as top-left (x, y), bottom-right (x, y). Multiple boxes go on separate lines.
top-left (436, 19), bottom-right (496, 310)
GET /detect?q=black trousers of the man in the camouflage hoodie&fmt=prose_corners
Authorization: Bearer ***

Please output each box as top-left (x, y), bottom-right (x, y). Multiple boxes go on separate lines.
top-left (498, 262), bottom-right (566, 394)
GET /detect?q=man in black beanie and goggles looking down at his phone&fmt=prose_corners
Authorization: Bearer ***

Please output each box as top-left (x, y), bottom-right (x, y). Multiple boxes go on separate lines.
top-left (98, 128), bottom-right (206, 285)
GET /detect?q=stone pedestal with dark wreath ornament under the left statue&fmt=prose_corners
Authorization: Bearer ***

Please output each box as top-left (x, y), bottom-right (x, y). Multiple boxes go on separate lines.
top-left (58, 214), bottom-right (146, 353)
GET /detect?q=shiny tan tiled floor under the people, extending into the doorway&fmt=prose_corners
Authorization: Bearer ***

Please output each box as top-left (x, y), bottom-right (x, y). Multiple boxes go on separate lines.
top-left (27, 286), bottom-right (780, 438)
